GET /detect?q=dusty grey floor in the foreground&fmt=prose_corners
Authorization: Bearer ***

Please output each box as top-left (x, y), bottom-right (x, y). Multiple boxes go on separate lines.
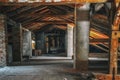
top-left (0, 63), bottom-right (95, 80)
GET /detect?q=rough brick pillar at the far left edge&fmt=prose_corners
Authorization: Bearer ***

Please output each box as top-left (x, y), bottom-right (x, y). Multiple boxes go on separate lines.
top-left (0, 14), bottom-right (6, 67)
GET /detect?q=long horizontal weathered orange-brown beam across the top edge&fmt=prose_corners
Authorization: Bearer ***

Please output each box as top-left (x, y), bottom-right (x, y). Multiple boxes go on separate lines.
top-left (0, 0), bottom-right (120, 6)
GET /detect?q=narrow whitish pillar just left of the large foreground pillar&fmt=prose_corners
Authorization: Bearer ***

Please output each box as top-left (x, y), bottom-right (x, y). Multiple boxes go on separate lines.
top-left (67, 24), bottom-right (73, 57)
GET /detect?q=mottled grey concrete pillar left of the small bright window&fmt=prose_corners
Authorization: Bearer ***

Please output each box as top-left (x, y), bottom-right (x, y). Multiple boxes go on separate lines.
top-left (23, 30), bottom-right (32, 57)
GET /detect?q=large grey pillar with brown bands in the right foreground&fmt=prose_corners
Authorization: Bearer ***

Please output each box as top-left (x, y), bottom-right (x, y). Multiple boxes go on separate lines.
top-left (75, 3), bottom-right (90, 72)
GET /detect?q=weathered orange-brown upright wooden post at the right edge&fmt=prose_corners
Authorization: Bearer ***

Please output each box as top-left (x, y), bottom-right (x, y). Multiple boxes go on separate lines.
top-left (109, 1), bottom-right (120, 77)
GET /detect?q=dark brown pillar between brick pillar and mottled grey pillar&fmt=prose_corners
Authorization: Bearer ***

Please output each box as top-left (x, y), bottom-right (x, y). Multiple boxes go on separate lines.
top-left (12, 24), bottom-right (23, 62)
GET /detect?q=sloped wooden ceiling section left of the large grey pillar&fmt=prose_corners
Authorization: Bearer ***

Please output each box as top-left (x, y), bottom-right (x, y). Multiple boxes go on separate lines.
top-left (0, 5), bottom-right (74, 31)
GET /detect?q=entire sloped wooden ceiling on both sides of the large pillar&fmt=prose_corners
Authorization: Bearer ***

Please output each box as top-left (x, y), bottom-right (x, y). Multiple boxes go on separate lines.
top-left (0, 4), bottom-right (110, 39)
